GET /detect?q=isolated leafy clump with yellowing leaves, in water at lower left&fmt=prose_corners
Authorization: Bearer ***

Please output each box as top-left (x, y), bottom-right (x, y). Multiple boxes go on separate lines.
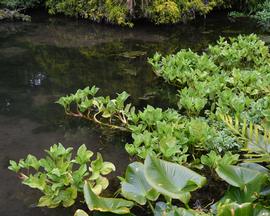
top-left (9, 143), bottom-right (115, 208)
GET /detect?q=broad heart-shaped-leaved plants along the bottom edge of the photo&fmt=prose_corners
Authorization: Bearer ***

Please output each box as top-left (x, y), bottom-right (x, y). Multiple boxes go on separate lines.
top-left (75, 155), bottom-right (270, 216)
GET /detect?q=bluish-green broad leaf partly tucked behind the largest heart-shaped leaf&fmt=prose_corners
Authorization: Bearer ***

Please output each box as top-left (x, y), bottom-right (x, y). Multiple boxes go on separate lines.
top-left (121, 162), bottom-right (159, 205)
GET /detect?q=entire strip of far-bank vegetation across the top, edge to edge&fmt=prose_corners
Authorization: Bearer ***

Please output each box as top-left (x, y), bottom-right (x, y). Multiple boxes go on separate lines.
top-left (0, 0), bottom-right (270, 27)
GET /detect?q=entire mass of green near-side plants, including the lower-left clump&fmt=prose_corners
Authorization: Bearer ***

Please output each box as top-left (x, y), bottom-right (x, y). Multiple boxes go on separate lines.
top-left (9, 34), bottom-right (270, 216)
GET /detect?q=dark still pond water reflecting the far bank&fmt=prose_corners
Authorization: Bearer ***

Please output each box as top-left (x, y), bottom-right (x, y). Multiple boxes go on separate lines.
top-left (0, 14), bottom-right (269, 216)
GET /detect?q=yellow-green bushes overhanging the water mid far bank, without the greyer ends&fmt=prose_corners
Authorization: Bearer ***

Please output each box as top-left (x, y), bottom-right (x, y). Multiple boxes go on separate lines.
top-left (46, 0), bottom-right (230, 26)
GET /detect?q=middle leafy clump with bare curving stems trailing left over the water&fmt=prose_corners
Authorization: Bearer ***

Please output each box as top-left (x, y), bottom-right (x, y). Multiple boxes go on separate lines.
top-left (57, 86), bottom-right (240, 163)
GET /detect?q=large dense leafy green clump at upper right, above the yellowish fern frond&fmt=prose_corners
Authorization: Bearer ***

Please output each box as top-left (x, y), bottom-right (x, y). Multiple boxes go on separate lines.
top-left (149, 35), bottom-right (270, 123)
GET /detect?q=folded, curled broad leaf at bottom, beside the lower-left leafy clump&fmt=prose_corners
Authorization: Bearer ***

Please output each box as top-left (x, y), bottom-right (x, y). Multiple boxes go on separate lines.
top-left (83, 181), bottom-right (133, 214)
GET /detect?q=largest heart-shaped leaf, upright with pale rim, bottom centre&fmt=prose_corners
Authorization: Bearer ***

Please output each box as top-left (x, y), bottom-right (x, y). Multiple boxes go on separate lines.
top-left (144, 155), bottom-right (206, 203)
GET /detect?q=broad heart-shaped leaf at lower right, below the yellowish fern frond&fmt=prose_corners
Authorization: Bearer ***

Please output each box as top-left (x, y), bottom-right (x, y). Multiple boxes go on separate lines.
top-left (216, 165), bottom-right (267, 189)
